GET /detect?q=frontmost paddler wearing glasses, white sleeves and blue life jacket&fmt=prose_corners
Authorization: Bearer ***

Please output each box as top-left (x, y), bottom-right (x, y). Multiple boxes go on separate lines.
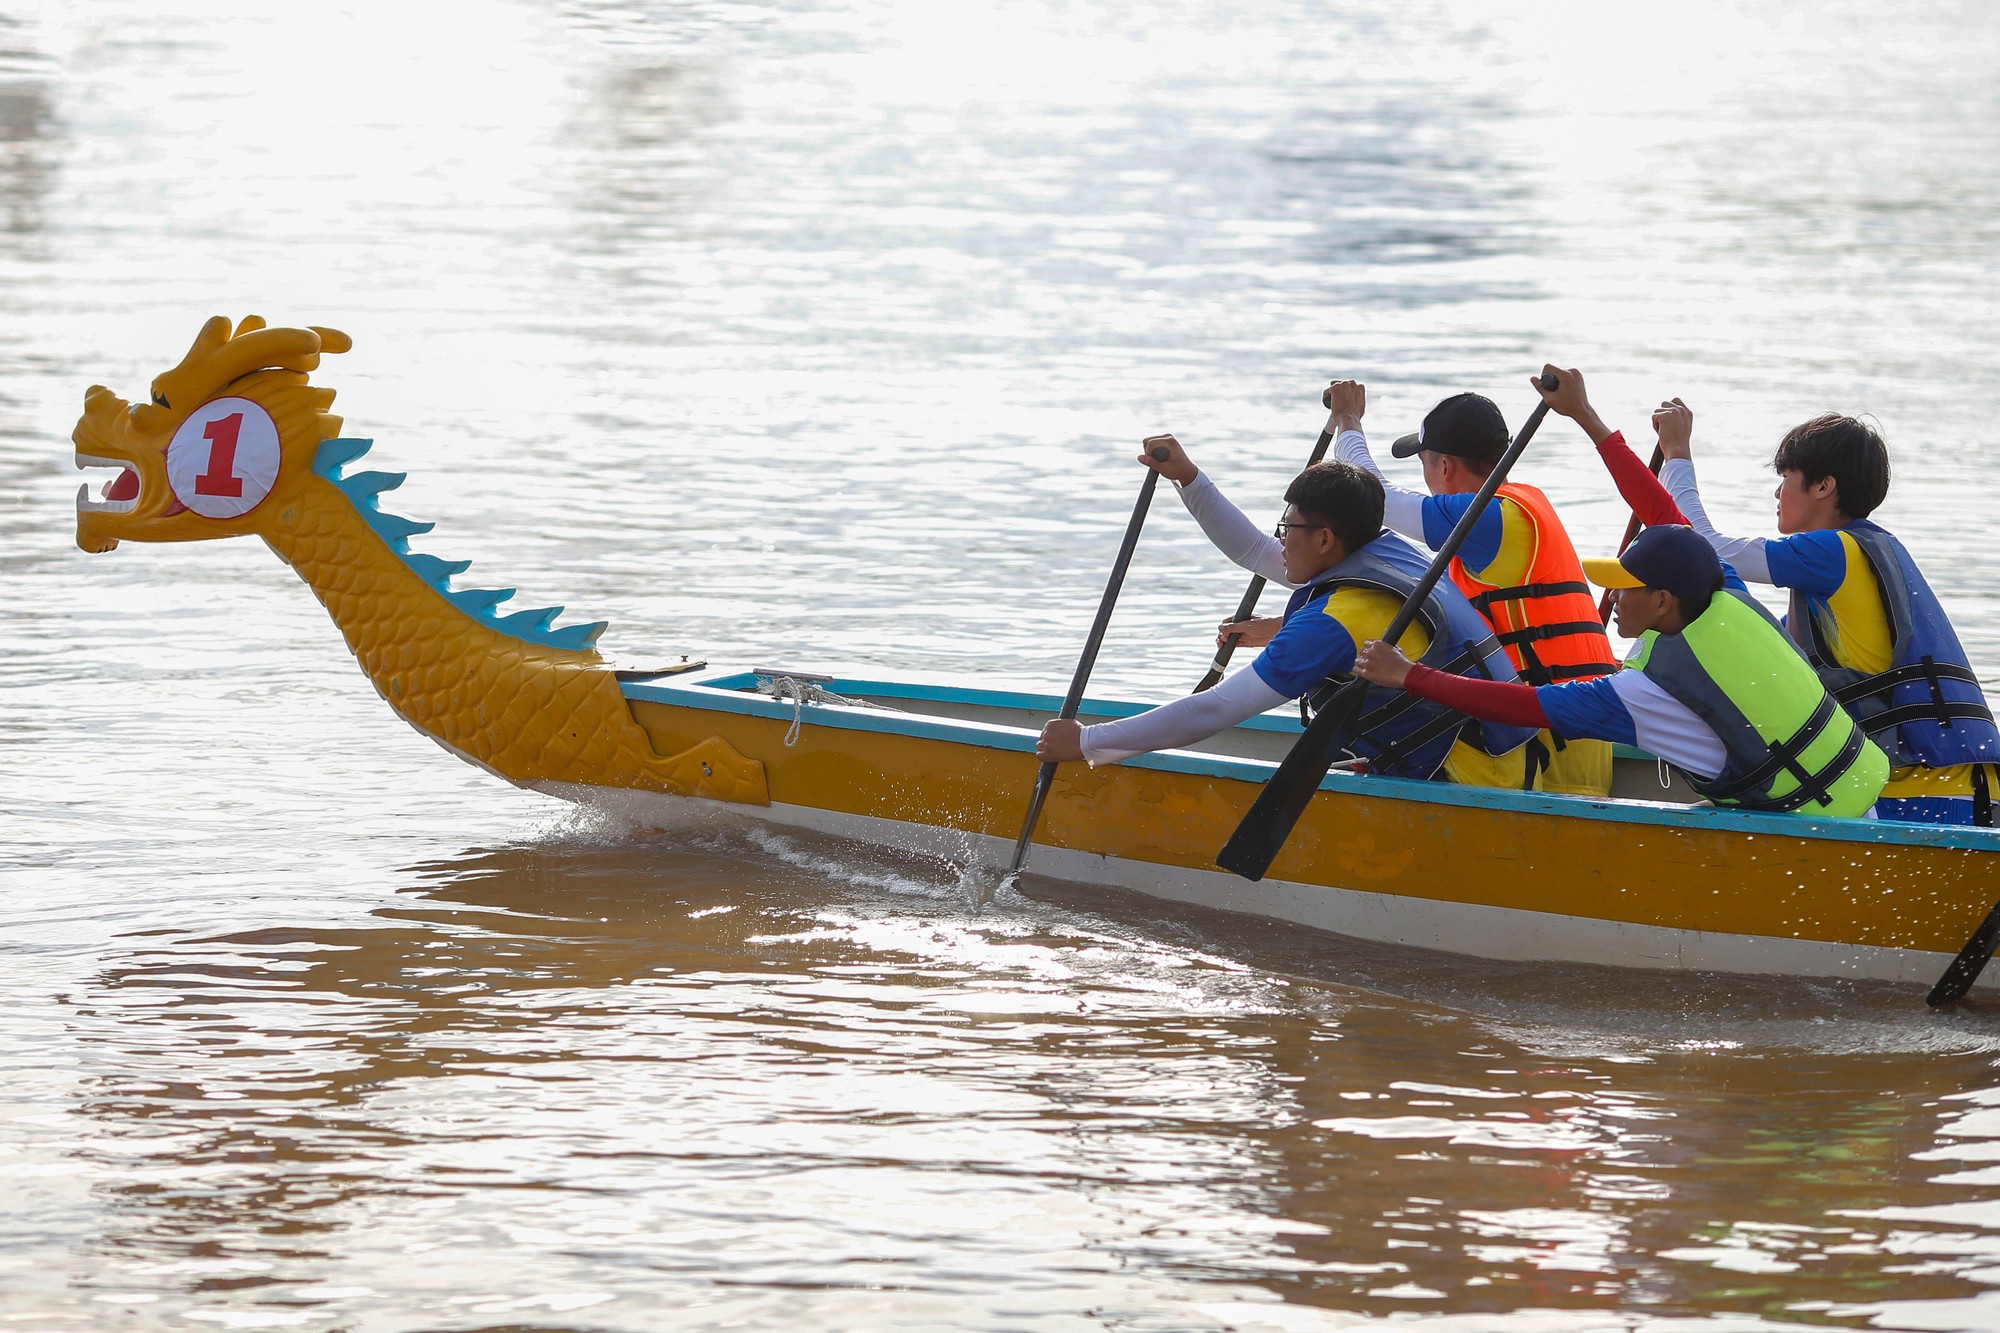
top-left (1036, 448), bottom-right (1536, 789)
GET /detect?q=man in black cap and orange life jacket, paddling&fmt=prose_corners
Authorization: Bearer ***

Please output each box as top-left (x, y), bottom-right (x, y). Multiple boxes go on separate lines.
top-left (1296, 380), bottom-right (1618, 797)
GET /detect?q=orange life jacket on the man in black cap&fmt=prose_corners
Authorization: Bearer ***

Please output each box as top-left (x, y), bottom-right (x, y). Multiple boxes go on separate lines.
top-left (1452, 482), bottom-right (1618, 685)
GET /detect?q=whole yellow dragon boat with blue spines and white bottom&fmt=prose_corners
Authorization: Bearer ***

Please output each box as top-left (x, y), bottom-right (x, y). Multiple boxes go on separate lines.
top-left (74, 318), bottom-right (2000, 983)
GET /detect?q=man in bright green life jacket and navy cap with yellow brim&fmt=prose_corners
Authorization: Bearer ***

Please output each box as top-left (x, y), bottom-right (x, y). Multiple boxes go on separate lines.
top-left (1354, 524), bottom-right (1888, 817)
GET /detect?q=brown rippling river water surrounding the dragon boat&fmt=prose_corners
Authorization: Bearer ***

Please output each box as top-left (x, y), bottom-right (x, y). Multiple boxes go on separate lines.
top-left (0, 0), bottom-right (2000, 1333)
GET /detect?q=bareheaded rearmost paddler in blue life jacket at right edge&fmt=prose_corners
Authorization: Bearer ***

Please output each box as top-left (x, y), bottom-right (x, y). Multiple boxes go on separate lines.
top-left (1544, 366), bottom-right (2000, 827)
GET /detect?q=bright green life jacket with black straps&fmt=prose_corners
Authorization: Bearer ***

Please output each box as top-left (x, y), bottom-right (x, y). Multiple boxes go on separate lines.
top-left (1628, 588), bottom-right (1888, 817)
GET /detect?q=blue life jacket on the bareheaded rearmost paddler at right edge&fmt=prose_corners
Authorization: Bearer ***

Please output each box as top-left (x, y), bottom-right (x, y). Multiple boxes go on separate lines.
top-left (1786, 518), bottom-right (2000, 769)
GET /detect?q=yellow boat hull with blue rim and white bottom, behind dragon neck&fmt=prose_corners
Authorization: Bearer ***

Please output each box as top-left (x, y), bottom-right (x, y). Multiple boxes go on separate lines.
top-left (600, 675), bottom-right (2000, 983)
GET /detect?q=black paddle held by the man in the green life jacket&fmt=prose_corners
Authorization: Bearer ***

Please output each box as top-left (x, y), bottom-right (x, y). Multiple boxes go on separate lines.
top-left (1216, 374), bottom-right (1558, 879)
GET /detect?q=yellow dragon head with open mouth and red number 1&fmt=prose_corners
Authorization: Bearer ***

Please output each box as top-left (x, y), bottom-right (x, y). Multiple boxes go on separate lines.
top-left (70, 314), bottom-right (352, 552)
